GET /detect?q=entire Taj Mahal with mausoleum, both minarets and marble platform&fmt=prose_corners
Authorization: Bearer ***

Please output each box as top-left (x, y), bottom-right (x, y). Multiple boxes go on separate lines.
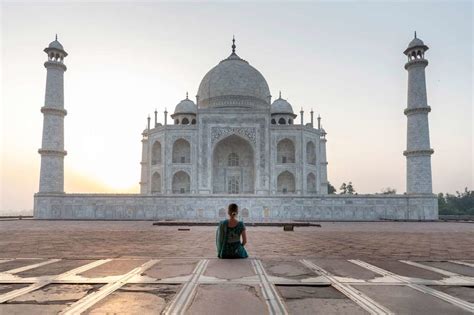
top-left (34, 34), bottom-right (438, 221)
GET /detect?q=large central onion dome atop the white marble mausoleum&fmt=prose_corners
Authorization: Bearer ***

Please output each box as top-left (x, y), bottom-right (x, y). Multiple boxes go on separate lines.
top-left (198, 52), bottom-right (271, 108)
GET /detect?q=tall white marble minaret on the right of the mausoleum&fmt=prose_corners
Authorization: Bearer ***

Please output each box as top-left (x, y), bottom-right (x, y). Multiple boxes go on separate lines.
top-left (403, 32), bottom-right (434, 194)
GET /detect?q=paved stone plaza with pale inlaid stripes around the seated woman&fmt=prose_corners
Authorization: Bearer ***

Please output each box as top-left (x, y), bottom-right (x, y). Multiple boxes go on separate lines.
top-left (0, 220), bottom-right (474, 315)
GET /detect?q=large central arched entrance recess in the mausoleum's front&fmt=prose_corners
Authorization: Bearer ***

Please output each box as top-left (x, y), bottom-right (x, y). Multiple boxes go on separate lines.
top-left (212, 135), bottom-right (255, 194)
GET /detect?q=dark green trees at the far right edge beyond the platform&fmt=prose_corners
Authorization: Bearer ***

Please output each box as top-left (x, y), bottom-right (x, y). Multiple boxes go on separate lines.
top-left (438, 187), bottom-right (474, 215)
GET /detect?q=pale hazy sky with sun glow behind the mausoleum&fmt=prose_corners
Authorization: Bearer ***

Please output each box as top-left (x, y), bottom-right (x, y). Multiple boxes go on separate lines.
top-left (0, 1), bottom-right (474, 213)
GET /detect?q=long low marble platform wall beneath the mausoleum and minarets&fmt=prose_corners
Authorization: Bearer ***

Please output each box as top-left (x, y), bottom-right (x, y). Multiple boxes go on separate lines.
top-left (34, 194), bottom-right (438, 221)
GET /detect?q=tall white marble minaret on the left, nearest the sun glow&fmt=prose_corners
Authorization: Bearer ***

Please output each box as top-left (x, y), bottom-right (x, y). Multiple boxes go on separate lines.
top-left (38, 35), bottom-right (67, 193)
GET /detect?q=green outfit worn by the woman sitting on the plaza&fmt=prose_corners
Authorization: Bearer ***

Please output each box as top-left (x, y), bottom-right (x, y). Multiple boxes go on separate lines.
top-left (216, 220), bottom-right (248, 258)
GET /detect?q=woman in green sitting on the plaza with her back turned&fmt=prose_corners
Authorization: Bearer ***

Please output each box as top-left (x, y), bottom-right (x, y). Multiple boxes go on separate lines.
top-left (216, 203), bottom-right (248, 258)
